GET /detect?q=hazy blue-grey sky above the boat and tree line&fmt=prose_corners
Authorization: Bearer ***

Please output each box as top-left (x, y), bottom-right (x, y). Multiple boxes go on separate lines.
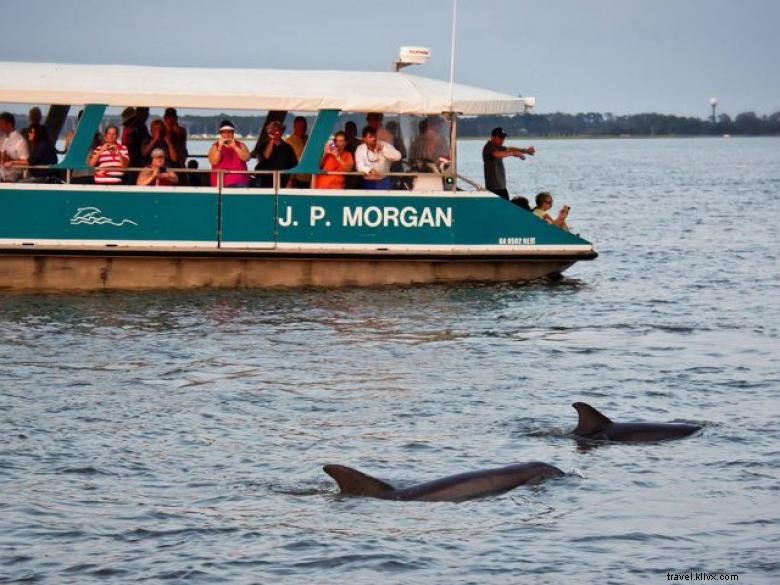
top-left (0, 0), bottom-right (780, 117)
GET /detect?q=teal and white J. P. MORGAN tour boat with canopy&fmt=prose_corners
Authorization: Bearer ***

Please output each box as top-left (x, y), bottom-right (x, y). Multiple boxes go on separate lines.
top-left (0, 62), bottom-right (597, 291)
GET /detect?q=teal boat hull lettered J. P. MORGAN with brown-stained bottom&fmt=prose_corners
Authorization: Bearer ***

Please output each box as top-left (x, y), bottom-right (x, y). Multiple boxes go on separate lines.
top-left (0, 184), bottom-right (596, 291)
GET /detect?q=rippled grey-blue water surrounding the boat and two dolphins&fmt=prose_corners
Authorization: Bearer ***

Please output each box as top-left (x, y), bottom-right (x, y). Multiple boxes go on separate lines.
top-left (0, 139), bottom-right (780, 584)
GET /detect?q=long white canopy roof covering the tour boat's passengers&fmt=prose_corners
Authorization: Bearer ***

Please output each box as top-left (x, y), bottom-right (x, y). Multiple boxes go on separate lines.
top-left (0, 62), bottom-right (527, 115)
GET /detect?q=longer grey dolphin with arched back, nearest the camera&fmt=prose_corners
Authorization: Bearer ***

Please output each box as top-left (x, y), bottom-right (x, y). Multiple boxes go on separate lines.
top-left (322, 461), bottom-right (563, 502)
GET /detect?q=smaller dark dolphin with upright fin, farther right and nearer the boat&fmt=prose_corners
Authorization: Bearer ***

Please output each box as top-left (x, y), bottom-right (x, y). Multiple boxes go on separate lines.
top-left (572, 402), bottom-right (701, 442)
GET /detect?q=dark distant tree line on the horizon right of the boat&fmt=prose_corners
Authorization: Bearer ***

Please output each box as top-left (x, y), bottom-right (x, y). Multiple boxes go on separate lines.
top-left (458, 112), bottom-right (780, 137)
